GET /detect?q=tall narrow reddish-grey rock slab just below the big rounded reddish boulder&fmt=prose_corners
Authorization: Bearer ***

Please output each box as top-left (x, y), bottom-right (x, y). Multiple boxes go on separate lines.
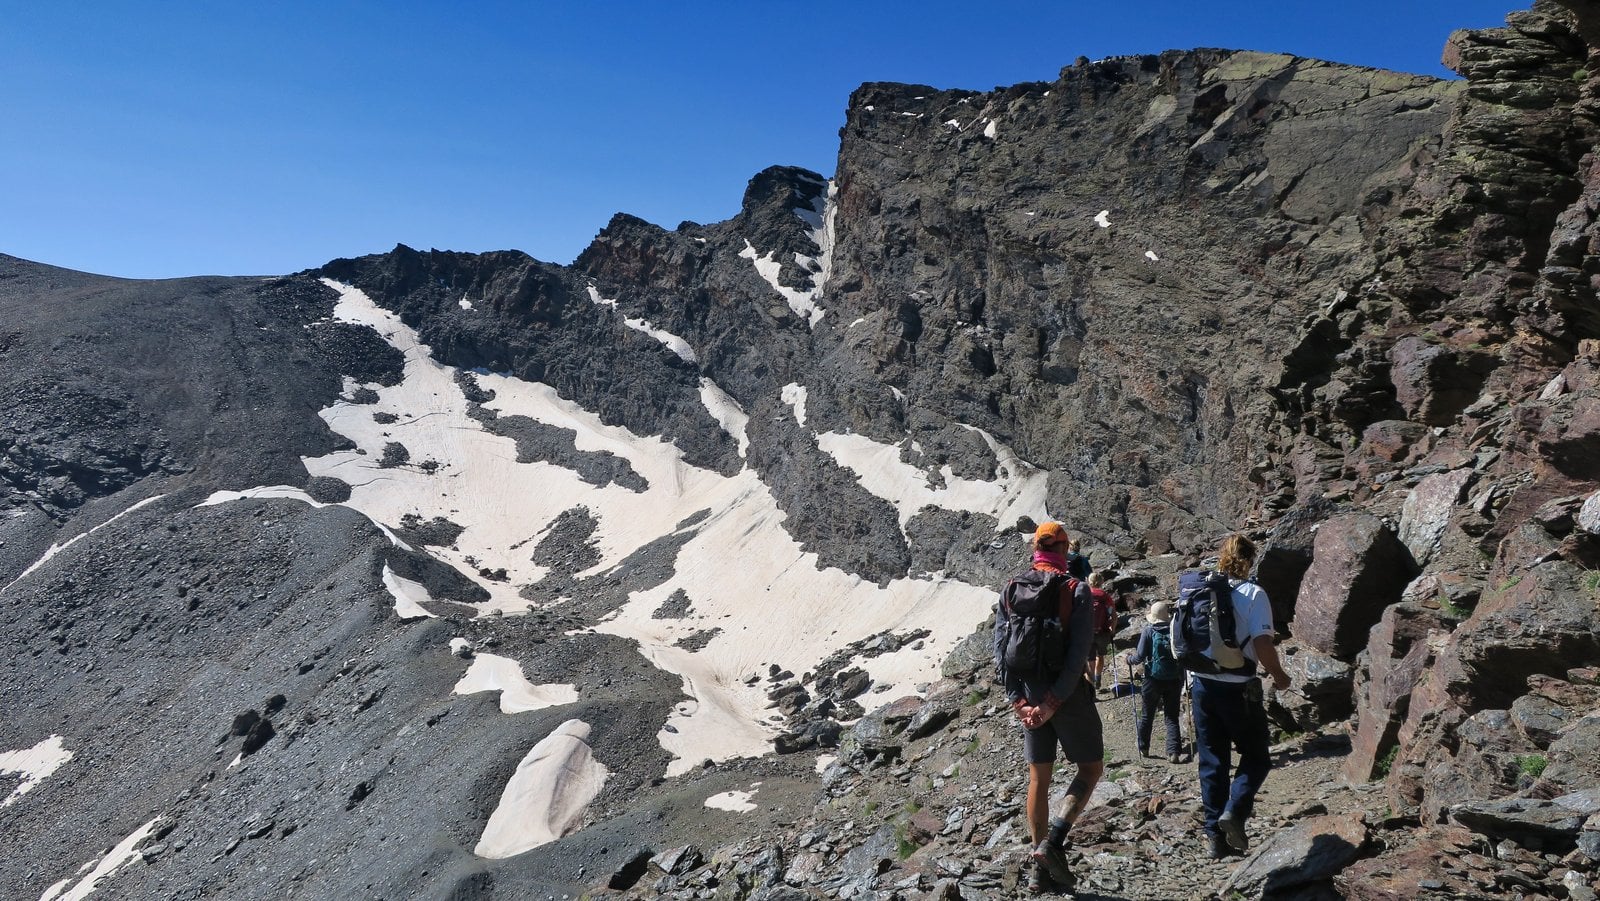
top-left (1344, 595), bottom-right (1448, 783)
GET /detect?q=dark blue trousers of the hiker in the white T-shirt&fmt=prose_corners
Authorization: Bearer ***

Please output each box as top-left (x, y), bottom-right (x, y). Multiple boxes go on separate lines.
top-left (1192, 675), bottom-right (1272, 835)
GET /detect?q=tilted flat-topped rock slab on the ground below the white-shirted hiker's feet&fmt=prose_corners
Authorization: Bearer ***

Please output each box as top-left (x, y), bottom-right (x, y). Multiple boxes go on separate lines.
top-left (1218, 813), bottom-right (1366, 898)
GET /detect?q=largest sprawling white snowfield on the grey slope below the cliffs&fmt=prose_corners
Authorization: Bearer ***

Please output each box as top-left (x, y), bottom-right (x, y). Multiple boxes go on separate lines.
top-left (304, 283), bottom-right (994, 773)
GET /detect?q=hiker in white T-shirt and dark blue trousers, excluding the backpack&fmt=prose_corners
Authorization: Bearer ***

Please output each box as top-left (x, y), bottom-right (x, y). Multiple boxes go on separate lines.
top-left (1190, 535), bottom-right (1290, 859)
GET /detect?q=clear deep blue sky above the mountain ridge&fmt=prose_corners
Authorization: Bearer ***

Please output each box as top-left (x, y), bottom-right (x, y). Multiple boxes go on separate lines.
top-left (0, 0), bottom-right (1526, 277)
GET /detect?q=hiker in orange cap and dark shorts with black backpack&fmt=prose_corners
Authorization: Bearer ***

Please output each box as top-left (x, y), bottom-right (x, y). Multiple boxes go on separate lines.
top-left (995, 522), bottom-right (1106, 891)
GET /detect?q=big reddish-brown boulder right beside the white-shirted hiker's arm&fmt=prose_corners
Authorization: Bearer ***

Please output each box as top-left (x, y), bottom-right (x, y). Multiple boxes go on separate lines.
top-left (1294, 514), bottom-right (1416, 661)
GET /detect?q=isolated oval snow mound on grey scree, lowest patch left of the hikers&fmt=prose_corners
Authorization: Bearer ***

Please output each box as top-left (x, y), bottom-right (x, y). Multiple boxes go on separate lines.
top-left (472, 720), bottom-right (610, 859)
